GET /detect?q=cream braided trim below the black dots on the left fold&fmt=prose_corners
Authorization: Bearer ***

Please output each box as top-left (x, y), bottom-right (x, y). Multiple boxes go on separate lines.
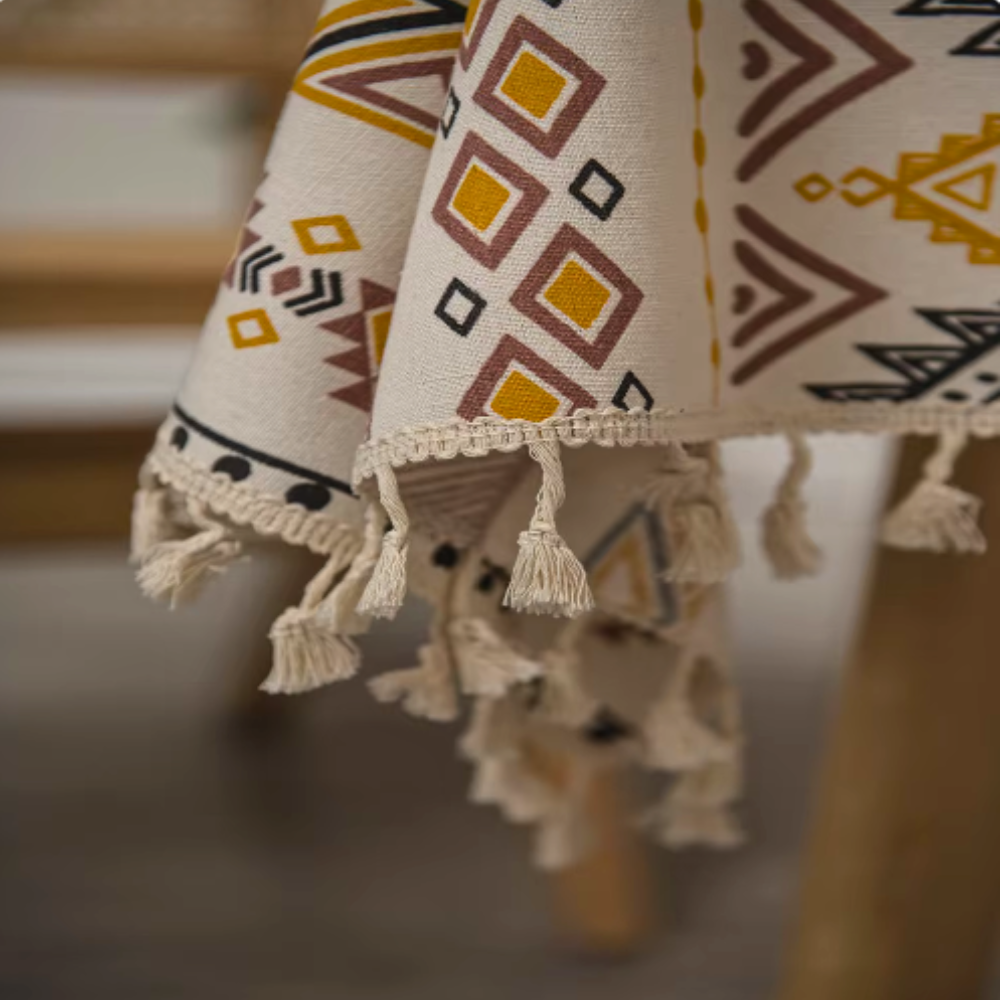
top-left (145, 430), bottom-right (361, 555)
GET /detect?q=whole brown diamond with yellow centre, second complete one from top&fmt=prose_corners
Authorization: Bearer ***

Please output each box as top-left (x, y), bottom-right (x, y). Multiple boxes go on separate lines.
top-left (432, 132), bottom-right (549, 270)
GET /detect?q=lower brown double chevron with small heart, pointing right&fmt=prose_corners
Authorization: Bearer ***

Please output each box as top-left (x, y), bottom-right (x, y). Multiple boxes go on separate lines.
top-left (731, 205), bottom-right (888, 385)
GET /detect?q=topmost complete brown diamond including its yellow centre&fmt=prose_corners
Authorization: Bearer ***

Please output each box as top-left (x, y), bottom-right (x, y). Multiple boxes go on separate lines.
top-left (474, 16), bottom-right (606, 159)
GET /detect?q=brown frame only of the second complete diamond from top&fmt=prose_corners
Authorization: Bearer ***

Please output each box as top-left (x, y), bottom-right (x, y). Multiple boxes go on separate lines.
top-left (431, 132), bottom-right (549, 271)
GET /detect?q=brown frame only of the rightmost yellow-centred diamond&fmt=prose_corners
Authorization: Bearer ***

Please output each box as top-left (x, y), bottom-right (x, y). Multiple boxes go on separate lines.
top-left (510, 224), bottom-right (645, 371)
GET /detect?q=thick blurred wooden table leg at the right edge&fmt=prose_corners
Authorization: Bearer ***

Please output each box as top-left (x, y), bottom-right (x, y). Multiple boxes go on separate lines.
top-left (779, 440), bottom-right (1000, 1000)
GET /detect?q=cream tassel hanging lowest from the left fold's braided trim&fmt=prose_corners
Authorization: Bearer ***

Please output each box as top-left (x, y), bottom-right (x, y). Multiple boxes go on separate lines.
top-left (260, 535), bottom-right (361, 694)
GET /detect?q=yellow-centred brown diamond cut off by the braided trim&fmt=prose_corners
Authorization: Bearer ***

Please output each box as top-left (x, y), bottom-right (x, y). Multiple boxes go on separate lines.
top-left (458, 335), bottom-right (597, 423)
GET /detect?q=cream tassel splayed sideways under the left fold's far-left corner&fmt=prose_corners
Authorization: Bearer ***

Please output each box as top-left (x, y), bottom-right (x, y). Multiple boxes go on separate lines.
top-left (137, 505), bottom-right (243, 608)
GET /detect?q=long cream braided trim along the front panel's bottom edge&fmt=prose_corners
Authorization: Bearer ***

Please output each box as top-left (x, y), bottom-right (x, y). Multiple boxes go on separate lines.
top-left (354, 403), bottom-right (1000, 488)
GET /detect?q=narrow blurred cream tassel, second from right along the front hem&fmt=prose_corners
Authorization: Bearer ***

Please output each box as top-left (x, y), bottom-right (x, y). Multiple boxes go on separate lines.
top-left (762, 434), bottom-right (822, 580)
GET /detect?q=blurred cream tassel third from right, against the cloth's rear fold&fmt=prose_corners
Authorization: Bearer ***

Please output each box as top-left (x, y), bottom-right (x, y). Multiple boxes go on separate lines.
top-left (648, 442), bottom-right (741, 583)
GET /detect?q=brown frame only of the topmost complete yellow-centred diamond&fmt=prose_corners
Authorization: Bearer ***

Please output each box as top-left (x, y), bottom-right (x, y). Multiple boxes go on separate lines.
top-left (473, 15), bottom-right (607, 160)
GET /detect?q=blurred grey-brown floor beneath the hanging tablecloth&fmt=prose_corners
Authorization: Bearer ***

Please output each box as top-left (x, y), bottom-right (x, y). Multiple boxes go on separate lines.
top-left (0, 446), bottom-right (1000, 1000)
